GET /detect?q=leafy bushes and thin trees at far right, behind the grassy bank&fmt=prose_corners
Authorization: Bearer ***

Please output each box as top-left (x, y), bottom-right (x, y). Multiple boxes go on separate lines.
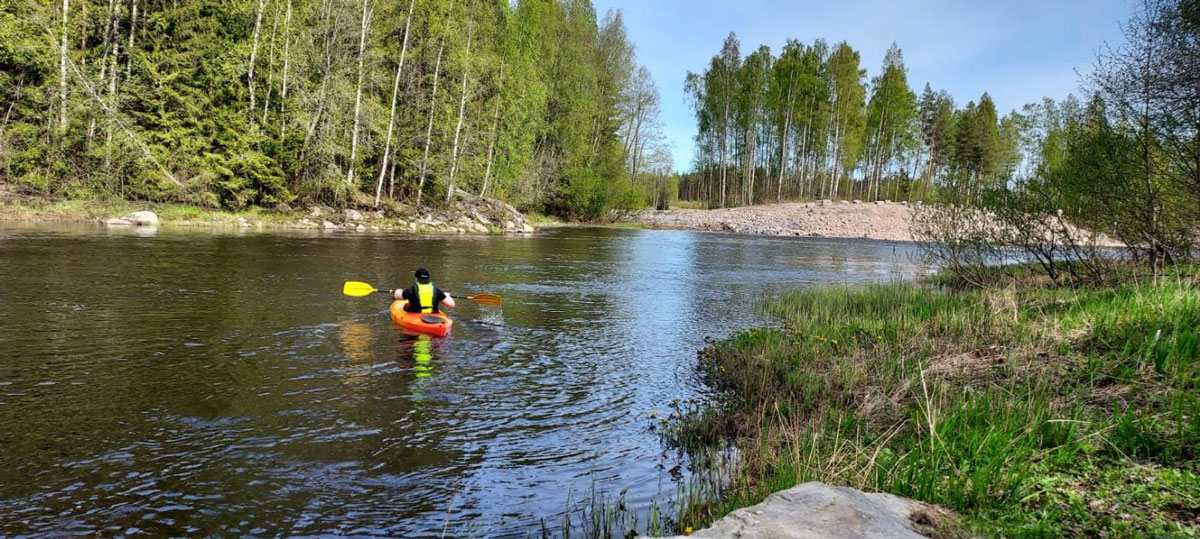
top-left (914, 0), bottom-right (1200, 277)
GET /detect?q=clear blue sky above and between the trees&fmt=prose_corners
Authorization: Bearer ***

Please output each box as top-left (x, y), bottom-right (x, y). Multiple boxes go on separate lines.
top-left (593, 0), bottom-right (1134, 172)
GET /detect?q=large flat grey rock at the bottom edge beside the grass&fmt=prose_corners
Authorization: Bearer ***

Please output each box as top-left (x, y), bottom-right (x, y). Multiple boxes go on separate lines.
top-left (657, 481), bottom-right (950, 539)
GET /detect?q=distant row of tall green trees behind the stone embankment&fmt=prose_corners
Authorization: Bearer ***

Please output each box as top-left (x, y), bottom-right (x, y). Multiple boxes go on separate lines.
top-left (680, 34), bottom-right (1022, 206)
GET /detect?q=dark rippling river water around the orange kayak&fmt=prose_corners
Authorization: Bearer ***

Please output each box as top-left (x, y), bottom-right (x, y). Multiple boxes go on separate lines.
top-left (0, 224), bottom-right (917, 537)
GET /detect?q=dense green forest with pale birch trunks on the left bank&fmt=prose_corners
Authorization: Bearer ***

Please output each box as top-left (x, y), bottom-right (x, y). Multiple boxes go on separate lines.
top-left (0, 0), bottom-right (671, 218)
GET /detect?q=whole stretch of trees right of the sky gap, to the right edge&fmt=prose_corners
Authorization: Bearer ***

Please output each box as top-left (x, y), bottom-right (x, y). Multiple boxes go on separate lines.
top-left (679, 0), bottom-right (1200, 244)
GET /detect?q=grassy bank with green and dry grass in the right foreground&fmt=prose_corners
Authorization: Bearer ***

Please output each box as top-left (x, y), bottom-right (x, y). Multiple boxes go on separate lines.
top-left (665, 270), bottom-right (1200, 537)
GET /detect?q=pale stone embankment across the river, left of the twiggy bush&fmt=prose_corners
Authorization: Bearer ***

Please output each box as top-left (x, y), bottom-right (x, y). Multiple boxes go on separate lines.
top-left (626, 200), bottom-right (913, 241)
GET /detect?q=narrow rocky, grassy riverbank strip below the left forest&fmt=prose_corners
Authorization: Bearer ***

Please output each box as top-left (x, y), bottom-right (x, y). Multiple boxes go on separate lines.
top-left (0, 184), bottom-right (544, 234)
